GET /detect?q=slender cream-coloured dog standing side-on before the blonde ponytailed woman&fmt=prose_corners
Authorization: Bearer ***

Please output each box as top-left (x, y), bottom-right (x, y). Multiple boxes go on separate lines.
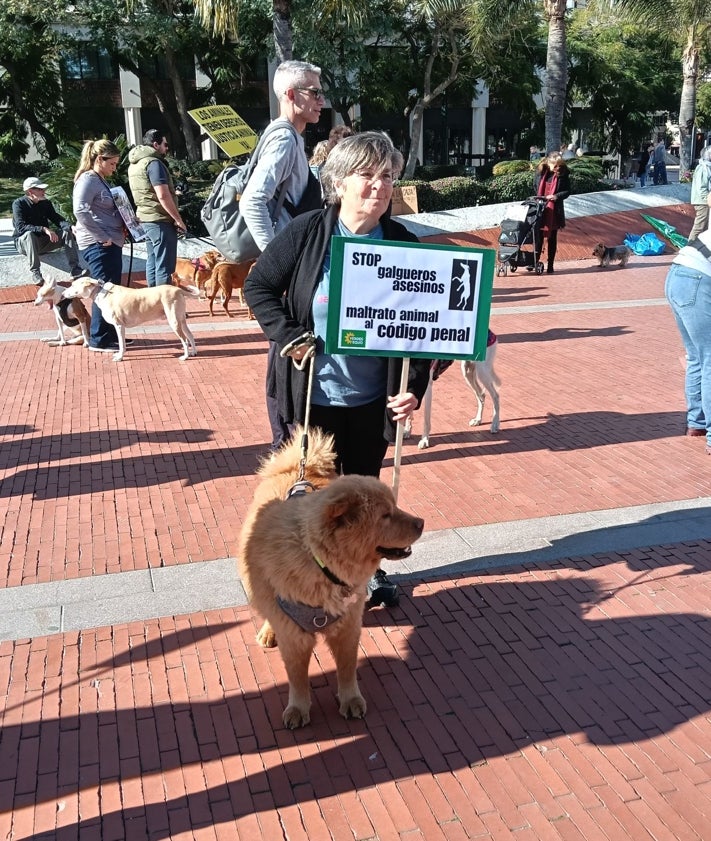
top-left (64, 277), bottom-right (200, 362)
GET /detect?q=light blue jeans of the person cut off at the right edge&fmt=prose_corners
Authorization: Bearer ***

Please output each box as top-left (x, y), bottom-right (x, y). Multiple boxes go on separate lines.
top-left (664, 263), bottom-right (711, 445)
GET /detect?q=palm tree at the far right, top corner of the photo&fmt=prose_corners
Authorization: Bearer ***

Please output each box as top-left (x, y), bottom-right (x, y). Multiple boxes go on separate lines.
top-left (607, 0), bottom-right (711, 172)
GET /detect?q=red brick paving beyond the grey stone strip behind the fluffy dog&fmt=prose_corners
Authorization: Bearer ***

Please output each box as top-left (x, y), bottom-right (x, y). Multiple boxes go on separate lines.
top-left (0, 246), bottom-right (709, 586)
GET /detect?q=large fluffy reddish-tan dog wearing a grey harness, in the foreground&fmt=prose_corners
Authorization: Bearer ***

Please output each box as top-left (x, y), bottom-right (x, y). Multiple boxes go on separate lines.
top-left (239, 432), bottom-right (424, 729)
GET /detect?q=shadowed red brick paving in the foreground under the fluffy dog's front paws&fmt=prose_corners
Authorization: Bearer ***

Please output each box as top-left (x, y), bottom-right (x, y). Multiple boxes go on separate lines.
top-left (0, 545), bottom-right (711, 841)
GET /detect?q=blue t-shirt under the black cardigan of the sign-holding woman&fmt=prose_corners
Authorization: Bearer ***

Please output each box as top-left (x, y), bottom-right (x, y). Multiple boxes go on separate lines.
top-left (311, 219), bottom-right (387, 407)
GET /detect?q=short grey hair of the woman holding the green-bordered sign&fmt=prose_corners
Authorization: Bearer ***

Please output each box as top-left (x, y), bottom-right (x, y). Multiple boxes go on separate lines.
top-left (321, 131), bottom-right (403, 204)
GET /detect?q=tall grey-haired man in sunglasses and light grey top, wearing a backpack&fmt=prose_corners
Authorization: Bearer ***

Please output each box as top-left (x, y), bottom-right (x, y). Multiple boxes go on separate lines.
top-left (239, 61), bottom-right (325, 450)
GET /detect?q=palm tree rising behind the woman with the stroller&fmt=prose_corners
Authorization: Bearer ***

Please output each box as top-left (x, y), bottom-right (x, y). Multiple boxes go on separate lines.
top-left (467, 0), bottom-right (568, 156)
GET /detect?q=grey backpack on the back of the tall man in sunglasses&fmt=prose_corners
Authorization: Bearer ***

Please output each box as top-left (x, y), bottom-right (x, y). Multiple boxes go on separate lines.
top-left (200, 120), bottom-right (297, 263)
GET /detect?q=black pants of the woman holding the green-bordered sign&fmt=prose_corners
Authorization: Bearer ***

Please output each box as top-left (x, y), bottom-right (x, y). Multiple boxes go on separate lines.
top-left (309, 397), bottom-right (388, 478)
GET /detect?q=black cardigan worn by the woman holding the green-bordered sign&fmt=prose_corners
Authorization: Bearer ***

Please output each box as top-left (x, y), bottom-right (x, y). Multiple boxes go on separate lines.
top-left (244, 206), bottom-right (429, 442)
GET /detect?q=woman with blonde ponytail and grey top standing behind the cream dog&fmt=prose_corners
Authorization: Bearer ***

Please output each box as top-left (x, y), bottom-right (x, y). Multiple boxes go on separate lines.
top-left (72, 140), bottom-right (125, 353)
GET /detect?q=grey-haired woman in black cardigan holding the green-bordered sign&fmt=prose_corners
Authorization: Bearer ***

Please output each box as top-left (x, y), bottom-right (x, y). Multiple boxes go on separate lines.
top-left (244, 132), bottom-right (429, 603)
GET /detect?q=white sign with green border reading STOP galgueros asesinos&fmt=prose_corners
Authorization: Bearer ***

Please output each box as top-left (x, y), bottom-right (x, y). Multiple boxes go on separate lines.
top-left (326, 237), bottom-right (496, 360)
